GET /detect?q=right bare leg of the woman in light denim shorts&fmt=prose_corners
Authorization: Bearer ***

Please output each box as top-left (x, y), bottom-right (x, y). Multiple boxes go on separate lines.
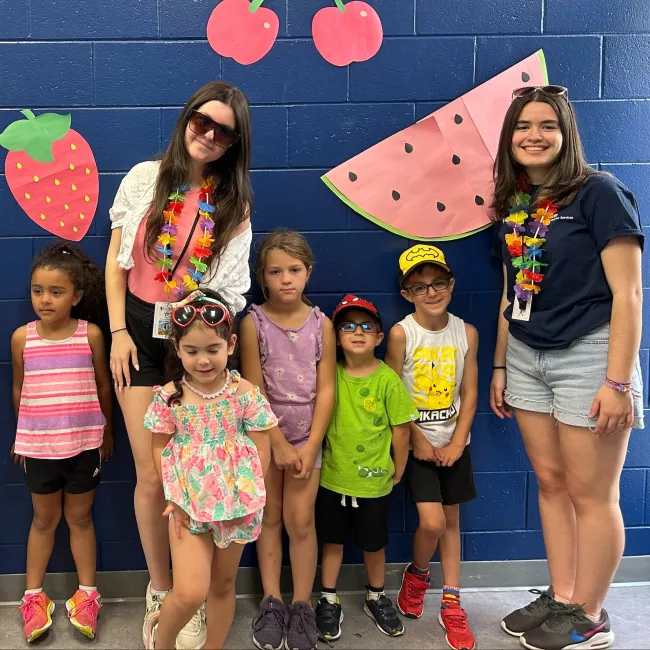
top-left (560, 424), bottom-right (630, 616)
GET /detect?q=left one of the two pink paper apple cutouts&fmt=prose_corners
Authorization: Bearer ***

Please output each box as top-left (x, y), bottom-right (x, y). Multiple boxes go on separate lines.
top-left (207, 0), bottom-right (280, 65)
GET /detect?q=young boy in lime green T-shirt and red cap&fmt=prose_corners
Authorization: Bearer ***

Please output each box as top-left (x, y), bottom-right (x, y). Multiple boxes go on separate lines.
top-left (316, 294), bottom-right (418, 640)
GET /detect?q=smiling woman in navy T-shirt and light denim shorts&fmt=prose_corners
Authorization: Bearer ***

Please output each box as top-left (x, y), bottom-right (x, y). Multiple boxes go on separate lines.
top-left (490, 86), bottom-right (643, 650)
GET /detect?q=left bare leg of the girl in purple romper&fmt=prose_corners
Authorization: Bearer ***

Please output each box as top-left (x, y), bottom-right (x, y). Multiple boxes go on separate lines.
top-left (257, 461), bottom-right (284, 600)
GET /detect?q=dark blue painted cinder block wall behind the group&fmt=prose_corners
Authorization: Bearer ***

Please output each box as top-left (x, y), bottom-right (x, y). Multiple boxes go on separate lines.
top-left (0, 0), bottom-right (650, 573)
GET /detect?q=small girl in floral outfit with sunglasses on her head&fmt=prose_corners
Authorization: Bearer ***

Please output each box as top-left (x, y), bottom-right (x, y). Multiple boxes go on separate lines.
top-left (144, 290), bottom-right (277, 650)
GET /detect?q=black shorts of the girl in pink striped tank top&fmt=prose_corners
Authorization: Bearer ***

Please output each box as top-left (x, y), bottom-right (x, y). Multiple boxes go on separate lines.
top-left (25, 449), bottom-right (102, 494)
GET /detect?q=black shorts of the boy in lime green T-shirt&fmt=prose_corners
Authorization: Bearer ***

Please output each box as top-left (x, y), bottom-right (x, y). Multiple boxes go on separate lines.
top-left (316, 486), bottom-right (390, 553)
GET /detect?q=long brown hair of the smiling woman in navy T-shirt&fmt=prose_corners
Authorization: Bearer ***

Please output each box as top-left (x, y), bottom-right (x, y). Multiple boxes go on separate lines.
top-left (492, 90), bottom-right (597, 221)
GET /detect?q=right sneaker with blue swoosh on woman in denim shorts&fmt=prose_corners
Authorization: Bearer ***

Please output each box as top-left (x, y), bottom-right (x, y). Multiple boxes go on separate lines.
top-left (519, 603), bottom-right (614, 650)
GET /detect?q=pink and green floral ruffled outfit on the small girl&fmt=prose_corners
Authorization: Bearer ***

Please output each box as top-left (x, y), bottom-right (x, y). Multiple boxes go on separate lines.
top-left (144, 370), bottom-right (277, 546)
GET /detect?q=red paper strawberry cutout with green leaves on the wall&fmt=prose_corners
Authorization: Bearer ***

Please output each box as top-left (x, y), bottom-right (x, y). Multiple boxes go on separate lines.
top-left (0, 110), bottom-right (99, 241)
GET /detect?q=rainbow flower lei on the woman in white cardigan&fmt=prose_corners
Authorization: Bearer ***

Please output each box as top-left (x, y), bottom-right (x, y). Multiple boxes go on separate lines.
top-left (154, 176), bottom-right (215, 298)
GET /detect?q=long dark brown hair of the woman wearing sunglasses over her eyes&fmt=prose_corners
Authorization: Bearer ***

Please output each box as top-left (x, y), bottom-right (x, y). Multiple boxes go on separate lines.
top-left (144, 81), bottom-right (252, 273)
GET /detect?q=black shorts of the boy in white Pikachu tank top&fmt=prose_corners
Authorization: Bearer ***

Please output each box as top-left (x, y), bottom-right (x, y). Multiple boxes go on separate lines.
top-left (404, 445), bottom-right (476, 506)
